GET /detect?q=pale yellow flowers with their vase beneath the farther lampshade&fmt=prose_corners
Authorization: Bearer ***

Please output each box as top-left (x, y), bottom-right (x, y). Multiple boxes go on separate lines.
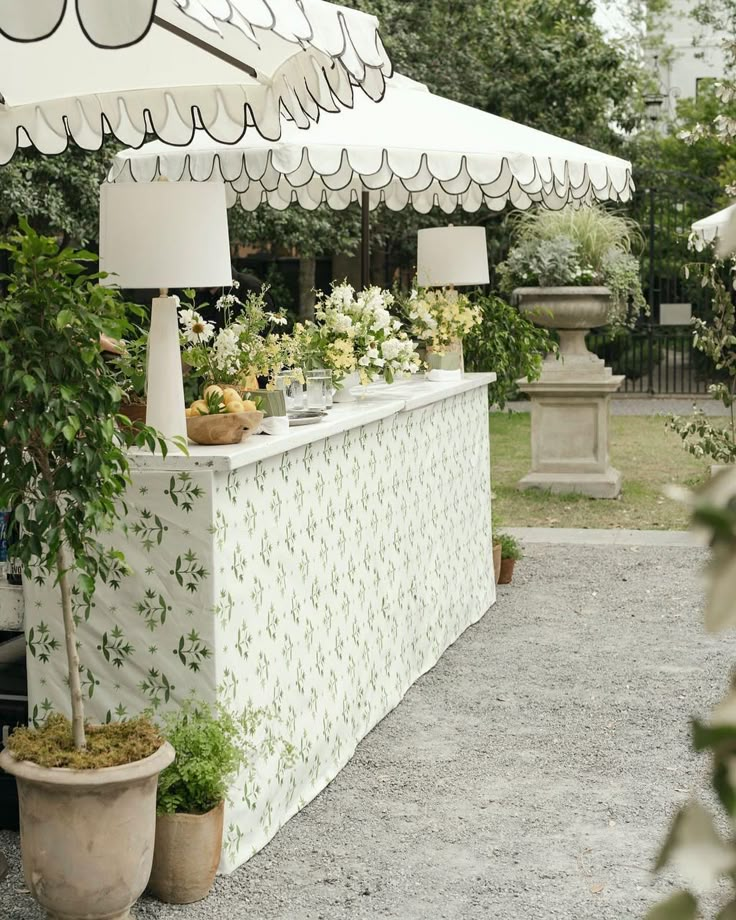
top-left (404, 289), bottom-right (481, 371)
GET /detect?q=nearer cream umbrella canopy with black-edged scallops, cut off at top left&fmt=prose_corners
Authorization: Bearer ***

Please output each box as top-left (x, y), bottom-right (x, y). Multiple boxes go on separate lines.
top-left (0, 0), bottom-right (391, 164)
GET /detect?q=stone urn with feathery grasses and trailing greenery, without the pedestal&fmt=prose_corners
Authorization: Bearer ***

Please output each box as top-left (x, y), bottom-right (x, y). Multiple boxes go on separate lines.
top-left (498, 205), bottom-right (648, 366)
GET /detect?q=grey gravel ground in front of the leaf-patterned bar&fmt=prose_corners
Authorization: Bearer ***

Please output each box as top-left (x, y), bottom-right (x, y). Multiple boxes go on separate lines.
top-left (0, 545), bottom-right (736, 920)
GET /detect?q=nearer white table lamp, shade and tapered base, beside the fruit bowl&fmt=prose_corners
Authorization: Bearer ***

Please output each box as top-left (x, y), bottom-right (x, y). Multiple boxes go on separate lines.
top-left (100, 182), bottom-right (232, 440)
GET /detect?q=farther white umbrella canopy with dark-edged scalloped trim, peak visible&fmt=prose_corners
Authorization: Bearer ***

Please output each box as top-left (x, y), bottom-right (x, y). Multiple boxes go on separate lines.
top-left (109, 76), bottom-right (633, 213)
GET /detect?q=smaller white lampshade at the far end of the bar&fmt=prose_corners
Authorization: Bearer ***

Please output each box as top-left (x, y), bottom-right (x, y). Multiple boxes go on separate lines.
top-left (417, 227), bottom-right (490, 287)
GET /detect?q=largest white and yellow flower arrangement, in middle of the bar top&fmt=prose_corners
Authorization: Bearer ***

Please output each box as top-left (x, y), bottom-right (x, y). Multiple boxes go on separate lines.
top-left (294, 283), bottom-right (421, 385)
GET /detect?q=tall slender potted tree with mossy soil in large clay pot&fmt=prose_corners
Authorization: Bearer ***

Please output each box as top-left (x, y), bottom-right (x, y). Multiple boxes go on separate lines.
top-left (0, 222), bottom-right (174, 920)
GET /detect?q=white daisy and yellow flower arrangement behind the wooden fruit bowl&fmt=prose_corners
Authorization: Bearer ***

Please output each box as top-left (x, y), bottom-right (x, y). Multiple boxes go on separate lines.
top-left (179, 282), bottom-right (293, 388)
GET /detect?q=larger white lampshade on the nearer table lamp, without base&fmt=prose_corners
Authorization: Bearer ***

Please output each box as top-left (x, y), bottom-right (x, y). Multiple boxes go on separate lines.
top-left (100, 182), bottom-right (232, 289)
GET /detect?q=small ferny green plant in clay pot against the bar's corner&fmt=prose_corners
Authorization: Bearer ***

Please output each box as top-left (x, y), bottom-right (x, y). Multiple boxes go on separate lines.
top-left (148, 700), bottom-right (260, 904)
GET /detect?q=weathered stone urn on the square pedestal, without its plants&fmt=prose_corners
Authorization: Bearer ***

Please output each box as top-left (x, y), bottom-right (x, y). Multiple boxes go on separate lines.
top-left (514, 287), bottom-right (611, 375)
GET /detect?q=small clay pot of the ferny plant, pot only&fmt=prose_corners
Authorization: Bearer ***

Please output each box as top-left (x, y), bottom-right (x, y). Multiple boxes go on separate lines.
top-left (148, 802), bottom-right (225, 904)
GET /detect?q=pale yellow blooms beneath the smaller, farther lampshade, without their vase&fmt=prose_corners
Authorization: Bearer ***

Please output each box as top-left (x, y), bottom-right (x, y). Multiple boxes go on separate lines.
top-left (404, 289), bottom-right (482, 352)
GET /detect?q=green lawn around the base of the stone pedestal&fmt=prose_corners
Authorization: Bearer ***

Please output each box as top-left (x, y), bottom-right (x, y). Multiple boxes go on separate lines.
top-left (491, 412), bottom-right (709, 530)
